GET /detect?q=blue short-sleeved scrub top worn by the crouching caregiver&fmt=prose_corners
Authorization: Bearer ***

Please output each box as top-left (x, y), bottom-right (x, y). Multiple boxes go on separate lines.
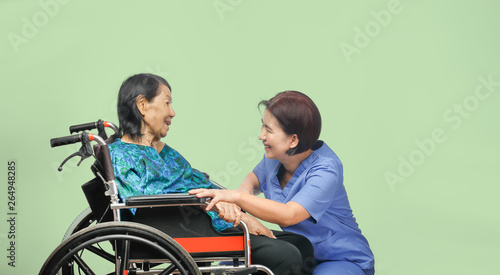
top-left (253, 141), bottom-right (374, 269)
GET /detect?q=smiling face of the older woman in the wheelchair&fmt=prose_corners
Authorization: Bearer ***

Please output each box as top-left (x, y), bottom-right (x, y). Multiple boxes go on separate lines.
top-left (143, 85), bottom-right (175, 142)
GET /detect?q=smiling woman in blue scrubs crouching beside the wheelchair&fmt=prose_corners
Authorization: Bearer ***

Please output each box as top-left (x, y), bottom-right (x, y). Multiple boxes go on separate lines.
top-left (190, 91), bottom-right (375, 275)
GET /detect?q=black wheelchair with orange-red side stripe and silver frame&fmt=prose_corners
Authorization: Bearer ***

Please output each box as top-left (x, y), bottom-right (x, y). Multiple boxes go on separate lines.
top-left (39, 120), bottom-right (273, 275)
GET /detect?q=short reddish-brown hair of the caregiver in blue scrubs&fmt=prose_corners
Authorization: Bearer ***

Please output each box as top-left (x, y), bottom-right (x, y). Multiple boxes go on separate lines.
top-left (258, 91), bottom-right (321, 156)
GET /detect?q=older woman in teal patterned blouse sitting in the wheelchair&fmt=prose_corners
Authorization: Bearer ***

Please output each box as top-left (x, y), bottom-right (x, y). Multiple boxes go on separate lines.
top-left (109, 74), bottom-right (313, 274)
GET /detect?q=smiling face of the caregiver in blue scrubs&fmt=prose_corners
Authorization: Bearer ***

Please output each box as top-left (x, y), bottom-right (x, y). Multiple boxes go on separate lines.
top-left (259, 109), bottom-right (297, 160)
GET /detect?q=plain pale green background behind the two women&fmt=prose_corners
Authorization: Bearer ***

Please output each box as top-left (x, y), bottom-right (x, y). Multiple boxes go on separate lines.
top-left (0, 0), bottom-right (500, 275)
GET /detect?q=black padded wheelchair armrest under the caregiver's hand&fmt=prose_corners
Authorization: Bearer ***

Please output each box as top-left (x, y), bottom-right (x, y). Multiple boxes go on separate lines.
top-left (125, 193), bottom-right (207, 207)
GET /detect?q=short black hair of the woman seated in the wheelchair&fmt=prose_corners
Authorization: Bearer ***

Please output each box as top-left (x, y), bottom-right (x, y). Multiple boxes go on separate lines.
top-left (117, 74), bottom-right (172, 140)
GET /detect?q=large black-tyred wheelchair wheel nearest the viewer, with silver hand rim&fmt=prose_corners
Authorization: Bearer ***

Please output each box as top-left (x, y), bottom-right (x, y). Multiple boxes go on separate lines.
top-left (39, 222), bottom-right (201, 275)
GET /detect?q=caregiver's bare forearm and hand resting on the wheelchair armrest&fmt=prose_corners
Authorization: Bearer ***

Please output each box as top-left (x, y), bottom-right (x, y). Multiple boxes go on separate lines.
top-left (189, 189), bottom-right (310, 227)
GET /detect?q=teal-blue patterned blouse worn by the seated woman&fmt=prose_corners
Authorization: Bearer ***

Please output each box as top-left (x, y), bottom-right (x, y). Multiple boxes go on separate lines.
top-left (109, 139), bottom-right (233, 231)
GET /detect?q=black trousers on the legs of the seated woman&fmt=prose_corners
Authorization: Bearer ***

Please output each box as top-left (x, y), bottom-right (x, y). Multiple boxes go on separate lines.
top-left (223, 228), bottom-right (314, 275)
